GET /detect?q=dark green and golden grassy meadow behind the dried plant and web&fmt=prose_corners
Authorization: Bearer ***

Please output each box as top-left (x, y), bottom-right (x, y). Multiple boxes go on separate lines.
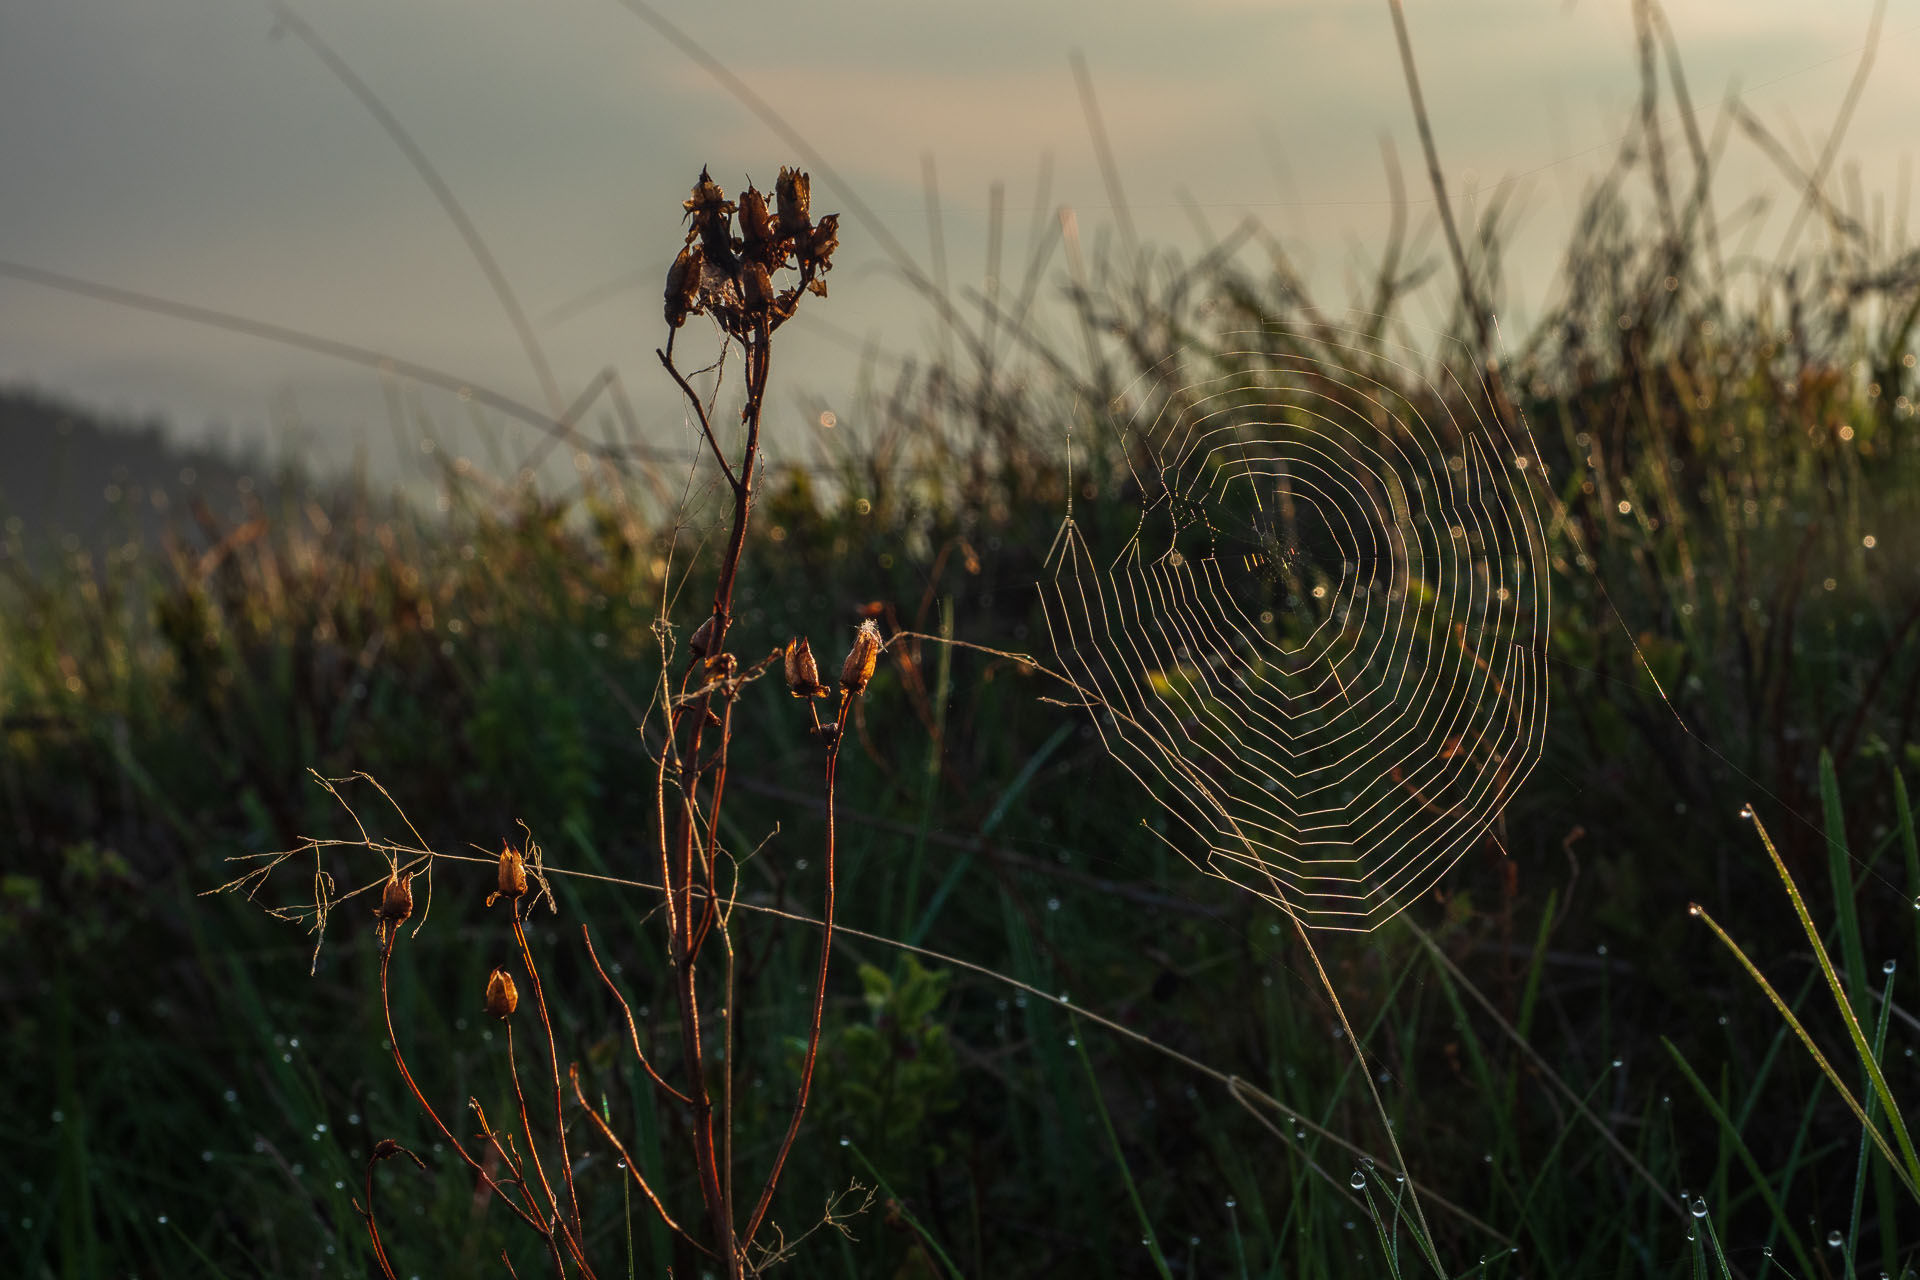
top-left (0, 72), bottom-right (1920, 1280)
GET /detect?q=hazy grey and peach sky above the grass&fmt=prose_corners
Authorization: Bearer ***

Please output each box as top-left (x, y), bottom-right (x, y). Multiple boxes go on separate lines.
top-left (0, 0), bottom-right (1920, 479)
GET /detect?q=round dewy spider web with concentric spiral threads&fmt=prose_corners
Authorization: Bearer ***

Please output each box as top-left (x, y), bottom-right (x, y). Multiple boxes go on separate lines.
top-left (1041, 328), bottom-right (1551, 929)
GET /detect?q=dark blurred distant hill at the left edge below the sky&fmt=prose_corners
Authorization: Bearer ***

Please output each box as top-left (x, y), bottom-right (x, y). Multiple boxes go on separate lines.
top-left (0, 388), bottom-right (290, 547)
